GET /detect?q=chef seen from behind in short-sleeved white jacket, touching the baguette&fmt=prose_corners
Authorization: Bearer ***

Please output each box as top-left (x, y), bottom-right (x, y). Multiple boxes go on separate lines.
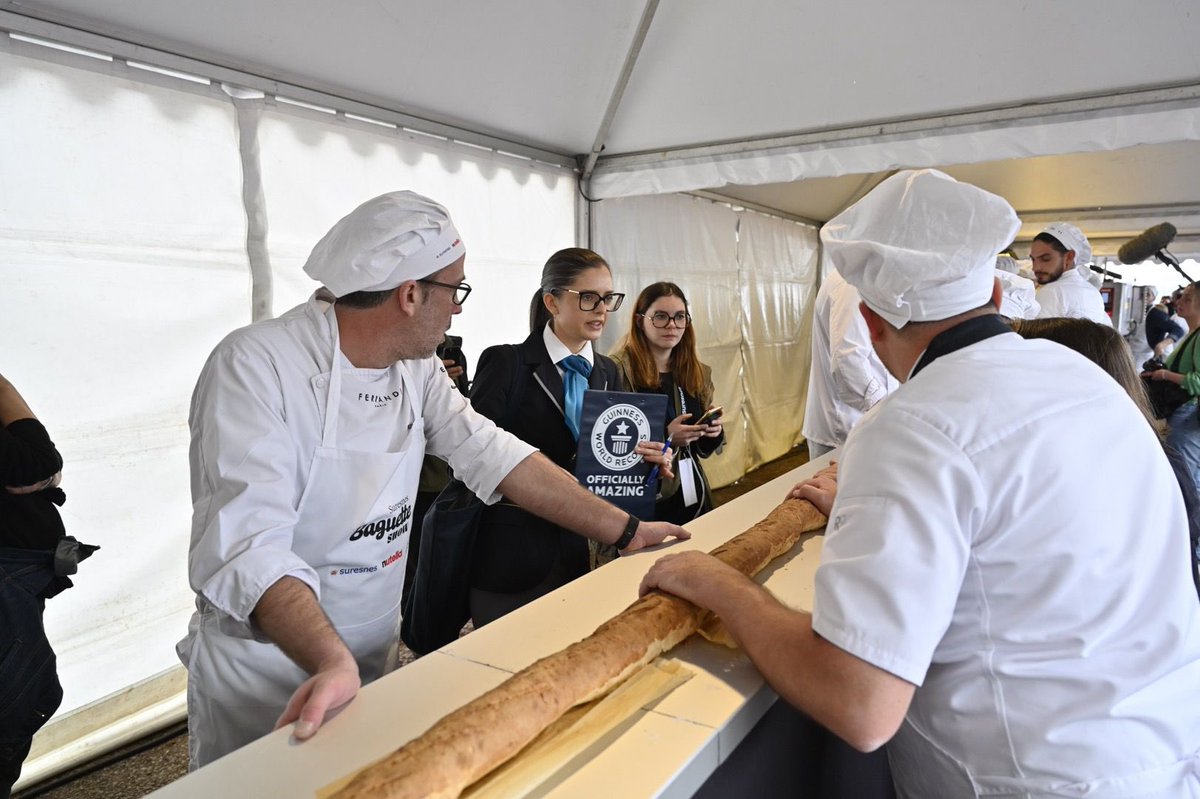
top-left (643, 170), bottom-right (1200, 799)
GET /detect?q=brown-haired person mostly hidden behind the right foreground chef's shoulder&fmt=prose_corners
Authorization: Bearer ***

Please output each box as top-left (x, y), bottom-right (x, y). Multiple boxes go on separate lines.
top-left (1012, 318), bottom-right (1200, 595)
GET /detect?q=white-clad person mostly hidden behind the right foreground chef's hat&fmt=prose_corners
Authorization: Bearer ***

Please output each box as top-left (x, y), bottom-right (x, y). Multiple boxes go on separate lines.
top-left (800, 270), bottom-right (900, 458)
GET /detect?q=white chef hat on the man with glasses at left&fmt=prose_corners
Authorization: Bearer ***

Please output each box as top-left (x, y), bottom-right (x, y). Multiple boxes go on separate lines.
top-left (304, 191), bottom-right (467, 296)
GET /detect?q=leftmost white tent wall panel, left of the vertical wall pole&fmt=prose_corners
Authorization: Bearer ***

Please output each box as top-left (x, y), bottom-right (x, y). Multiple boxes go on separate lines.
top-left (0, 44), bottom-right (248, 713)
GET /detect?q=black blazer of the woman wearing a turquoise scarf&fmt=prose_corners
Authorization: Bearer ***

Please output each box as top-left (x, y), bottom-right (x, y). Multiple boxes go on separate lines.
top-left (470, 330), bottom-right (624, 594)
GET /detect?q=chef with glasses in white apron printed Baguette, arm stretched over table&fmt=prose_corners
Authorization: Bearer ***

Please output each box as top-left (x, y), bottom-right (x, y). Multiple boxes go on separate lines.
top-left (178, 192), bottom-right (688, 768)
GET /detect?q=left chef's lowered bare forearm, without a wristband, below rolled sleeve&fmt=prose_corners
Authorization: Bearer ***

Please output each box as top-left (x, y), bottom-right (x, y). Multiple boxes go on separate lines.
top-left (251, 577), bottom-right (358, 674)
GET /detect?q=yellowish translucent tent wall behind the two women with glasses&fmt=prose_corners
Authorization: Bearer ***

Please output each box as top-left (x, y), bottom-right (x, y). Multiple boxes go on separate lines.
top-left (592, 194), bottom-right (817, 487)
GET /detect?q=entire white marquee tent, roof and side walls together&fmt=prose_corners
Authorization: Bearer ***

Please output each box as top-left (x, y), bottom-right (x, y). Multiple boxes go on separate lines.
top-left (0, 0), bottom-right (1200, 782)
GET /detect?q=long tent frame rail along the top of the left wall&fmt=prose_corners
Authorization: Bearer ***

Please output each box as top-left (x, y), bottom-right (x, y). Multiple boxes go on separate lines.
top-left (0, 2), bottom-right (577, 170)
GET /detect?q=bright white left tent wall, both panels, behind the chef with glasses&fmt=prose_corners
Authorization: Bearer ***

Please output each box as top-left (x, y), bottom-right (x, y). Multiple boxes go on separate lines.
top-left (0, 40), bottom-right (576, 785)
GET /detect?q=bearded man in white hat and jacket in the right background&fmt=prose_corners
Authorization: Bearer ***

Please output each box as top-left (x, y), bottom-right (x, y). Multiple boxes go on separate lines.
top-left (1030, 222), bottom-right (1112, 326)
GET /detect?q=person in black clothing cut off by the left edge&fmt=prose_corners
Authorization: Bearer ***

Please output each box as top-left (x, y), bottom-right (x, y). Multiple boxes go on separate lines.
top-left (0, 376), bottom-right (71, 799)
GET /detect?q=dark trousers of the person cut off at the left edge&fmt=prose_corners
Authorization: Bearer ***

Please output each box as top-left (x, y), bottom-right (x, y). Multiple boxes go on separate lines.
top-left (0, 548), bottom-right (62, 799)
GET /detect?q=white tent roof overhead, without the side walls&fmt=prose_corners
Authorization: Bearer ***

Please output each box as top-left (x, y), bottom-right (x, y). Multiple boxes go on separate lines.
top-left (0, 0), bottom-right (1200, 253)
